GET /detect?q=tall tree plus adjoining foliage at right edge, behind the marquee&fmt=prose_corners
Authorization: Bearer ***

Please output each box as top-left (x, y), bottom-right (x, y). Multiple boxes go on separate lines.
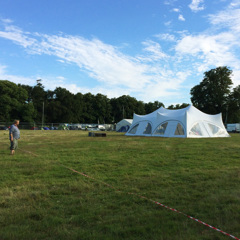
top-left (191, 67), bottom-right (240, 123)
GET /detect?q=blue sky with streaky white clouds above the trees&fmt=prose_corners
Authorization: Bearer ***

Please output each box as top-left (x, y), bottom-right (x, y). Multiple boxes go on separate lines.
top-left (0, 0), bottom-right (240, 106)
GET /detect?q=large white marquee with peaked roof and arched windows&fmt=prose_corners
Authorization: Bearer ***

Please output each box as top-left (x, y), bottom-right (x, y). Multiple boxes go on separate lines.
top-left (126, 105), bottom-right (229, 138)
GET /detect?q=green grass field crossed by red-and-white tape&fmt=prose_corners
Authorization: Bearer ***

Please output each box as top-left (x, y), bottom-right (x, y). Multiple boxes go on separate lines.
top-left (0, 130), bottom-right (240, 240)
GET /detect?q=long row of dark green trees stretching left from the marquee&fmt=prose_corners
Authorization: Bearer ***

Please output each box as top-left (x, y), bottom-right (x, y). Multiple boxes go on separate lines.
top-left (0, 80), bottom-right (169, 124)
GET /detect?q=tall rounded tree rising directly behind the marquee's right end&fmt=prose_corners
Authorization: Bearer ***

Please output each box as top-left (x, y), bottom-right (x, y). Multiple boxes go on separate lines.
top-left (190, 66), bottom-right (233, 114)
